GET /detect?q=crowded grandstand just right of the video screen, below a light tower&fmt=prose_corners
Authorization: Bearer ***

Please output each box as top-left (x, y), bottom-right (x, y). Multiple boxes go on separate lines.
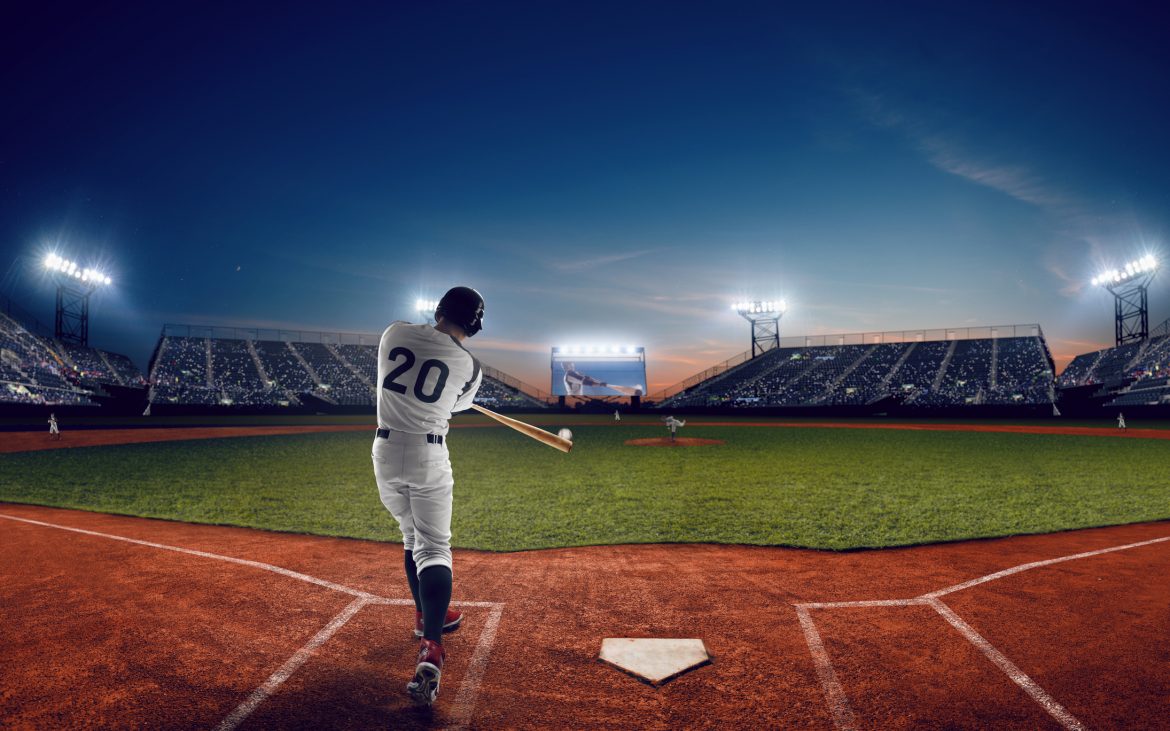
top-left (662, 337), bottom-right (1053, 408)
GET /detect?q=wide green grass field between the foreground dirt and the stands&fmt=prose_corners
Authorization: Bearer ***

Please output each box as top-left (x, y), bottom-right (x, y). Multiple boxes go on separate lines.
top-left (0, 425), bottom-right (1170, 551)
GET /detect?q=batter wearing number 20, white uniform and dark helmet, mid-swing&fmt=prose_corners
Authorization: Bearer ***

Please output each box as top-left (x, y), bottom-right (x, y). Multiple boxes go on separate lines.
top-left (373, 287), bottom-right (483, 705)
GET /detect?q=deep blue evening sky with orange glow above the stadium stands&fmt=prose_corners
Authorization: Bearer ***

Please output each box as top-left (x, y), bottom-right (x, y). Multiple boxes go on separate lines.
top-left (0, 1), bottom-right (1170, 391)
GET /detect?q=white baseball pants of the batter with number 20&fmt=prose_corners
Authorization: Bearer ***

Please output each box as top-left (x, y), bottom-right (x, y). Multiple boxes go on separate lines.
top-left (373, 432), bottom-right (455, 573)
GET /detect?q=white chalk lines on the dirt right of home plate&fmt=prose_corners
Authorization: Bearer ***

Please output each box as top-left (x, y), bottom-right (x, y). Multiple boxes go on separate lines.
top-left (793, 536), bottom-right (1170, 731)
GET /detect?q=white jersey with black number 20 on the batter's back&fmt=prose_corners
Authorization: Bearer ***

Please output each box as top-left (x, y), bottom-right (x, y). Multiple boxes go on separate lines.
top-left (377, 322), bottom-right (483, 434)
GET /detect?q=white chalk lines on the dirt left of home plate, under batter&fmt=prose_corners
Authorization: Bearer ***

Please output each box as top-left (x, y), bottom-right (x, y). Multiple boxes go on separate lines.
top-left (0, 513), bottom-right (507, 731)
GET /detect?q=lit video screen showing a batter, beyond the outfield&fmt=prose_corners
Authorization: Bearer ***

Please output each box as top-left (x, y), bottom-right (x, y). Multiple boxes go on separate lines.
top-left (552, 345), bottom-right (646, 398)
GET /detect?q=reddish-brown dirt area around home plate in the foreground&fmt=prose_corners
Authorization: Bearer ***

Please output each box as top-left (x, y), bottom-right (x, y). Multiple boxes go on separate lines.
top-left (0, 504), bottom-right (1170, 730)
